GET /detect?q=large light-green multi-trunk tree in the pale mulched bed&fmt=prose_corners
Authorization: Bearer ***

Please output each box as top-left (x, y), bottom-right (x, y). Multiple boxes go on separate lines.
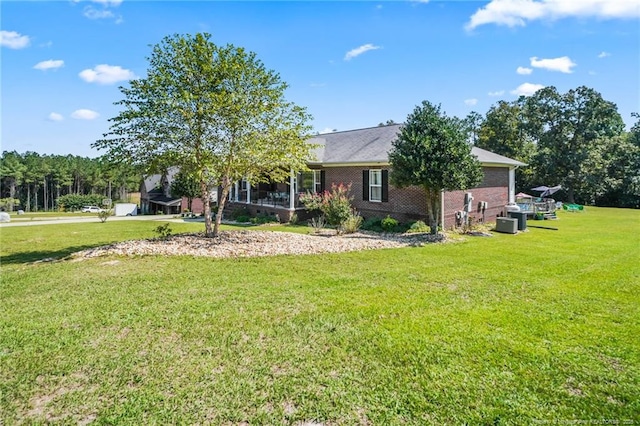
top-left (94, 34), bottom-right (311, 236)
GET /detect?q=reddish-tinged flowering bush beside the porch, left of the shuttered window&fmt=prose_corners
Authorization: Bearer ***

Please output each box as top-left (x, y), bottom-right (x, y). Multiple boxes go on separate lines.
top-left (300, 183), bottom-right (354, 226)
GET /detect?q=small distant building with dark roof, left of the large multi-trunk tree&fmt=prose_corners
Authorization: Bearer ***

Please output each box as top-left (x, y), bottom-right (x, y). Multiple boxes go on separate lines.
top-left (140, 167), bottom-right (182, 214)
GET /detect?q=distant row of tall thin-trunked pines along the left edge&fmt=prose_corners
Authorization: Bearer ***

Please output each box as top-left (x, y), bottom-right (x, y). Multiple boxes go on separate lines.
top-left (0, 151), bottom-right (141, 212)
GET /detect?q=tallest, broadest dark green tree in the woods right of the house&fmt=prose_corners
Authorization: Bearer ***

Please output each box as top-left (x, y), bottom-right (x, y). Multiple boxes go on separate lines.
top-left (525, 86), bottom-right (624, 203)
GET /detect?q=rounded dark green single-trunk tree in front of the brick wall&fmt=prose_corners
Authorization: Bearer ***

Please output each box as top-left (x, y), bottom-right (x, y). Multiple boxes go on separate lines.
top-left (389, 101), bottom-right (482, 234)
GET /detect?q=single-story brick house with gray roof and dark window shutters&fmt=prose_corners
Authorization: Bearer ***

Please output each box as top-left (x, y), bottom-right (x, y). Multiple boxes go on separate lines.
top-left (229, 124), bottom-right (525, 228)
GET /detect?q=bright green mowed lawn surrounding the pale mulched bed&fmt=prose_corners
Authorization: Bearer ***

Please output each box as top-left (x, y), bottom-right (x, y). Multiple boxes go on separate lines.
top-left (0, 208), bottom-right (640, 425)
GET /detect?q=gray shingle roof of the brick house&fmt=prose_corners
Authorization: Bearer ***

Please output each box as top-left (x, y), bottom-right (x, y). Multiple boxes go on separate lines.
top-left (309, 124), bottom-right (526, 166)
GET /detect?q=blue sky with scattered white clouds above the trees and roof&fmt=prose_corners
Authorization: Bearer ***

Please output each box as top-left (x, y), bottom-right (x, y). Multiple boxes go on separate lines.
top-left (0, 0), bottom-right (640, 157)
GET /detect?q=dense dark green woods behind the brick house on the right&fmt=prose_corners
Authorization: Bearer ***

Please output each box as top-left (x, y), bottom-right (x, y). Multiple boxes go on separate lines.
top-left (463, 86), bottom-right (640, 208)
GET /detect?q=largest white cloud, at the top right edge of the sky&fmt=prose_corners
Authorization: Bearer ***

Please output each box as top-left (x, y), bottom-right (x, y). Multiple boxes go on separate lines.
top-left (465, 0), bottom-right (640, 30)
